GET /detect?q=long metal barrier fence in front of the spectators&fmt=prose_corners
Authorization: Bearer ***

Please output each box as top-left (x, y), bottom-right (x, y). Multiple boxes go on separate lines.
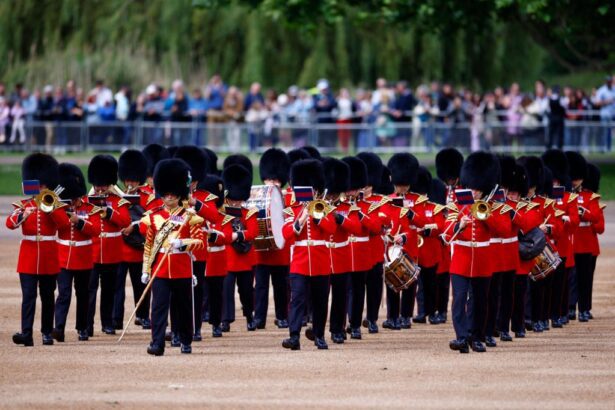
top-left (0, 121), bottom-right (615, 153)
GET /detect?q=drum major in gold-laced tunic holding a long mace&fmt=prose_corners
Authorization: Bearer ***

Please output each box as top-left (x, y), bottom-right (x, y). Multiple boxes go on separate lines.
top-left (141, 158), bottom-right (204, 356)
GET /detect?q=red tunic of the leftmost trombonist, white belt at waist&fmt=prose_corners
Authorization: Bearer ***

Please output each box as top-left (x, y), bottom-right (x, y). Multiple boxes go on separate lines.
top-left (6, 198), bottom-right (70, 275)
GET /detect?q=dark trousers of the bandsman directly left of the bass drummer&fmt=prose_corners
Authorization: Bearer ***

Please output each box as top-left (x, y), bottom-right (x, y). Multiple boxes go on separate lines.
top-left (222, 270), bottom-right (254, 323)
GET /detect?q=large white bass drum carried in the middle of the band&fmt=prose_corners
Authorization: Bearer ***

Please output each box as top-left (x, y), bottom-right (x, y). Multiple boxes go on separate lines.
top-left (246, 185), bottom-right (284, 251)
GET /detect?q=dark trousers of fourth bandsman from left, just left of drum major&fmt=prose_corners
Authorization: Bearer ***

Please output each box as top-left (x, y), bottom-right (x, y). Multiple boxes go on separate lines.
top-left (113, 262), bottom-right (150, 323)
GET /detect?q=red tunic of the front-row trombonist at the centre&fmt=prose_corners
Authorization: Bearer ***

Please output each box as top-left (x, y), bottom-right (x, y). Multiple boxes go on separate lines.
top-left (282, 203), bottom-right (337, 276)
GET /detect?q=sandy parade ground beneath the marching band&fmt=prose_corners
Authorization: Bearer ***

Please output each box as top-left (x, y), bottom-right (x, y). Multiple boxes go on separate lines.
top-left (0, 204), bottom-right (615, 409)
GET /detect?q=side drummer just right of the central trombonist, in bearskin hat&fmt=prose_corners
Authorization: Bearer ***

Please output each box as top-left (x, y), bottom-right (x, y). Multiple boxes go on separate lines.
top-left (387, 153), bottom-right (427, 329)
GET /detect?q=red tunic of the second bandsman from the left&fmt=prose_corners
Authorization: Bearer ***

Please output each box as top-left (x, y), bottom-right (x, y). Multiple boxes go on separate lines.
top-left (57, 198), bottom-right (102, 270)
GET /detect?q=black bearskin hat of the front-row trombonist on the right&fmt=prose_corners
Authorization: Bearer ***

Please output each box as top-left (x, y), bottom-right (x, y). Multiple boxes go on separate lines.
top-left (460, 151), bottom-right (500, 195)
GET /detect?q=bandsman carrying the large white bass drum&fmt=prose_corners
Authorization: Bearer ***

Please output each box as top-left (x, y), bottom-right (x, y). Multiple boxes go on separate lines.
top-left (254, 148), bottom-right (290, 329)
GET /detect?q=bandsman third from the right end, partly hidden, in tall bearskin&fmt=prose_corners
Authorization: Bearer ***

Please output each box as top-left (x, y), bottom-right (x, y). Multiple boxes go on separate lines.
top-left (542, 149), bottom-right (579, 330)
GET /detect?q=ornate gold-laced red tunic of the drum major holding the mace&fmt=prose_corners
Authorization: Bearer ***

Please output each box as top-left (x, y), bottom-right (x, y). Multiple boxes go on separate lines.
top-left (141, 206), bottom-right (204, 279)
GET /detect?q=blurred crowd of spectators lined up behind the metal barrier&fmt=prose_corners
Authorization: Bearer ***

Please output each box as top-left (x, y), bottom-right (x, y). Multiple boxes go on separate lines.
top-left (0, 75), bottom-right (615, 152)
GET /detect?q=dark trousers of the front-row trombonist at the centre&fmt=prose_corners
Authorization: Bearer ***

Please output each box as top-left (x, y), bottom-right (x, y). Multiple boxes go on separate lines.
top-left (288, 273), bottom-right (329, 337)
